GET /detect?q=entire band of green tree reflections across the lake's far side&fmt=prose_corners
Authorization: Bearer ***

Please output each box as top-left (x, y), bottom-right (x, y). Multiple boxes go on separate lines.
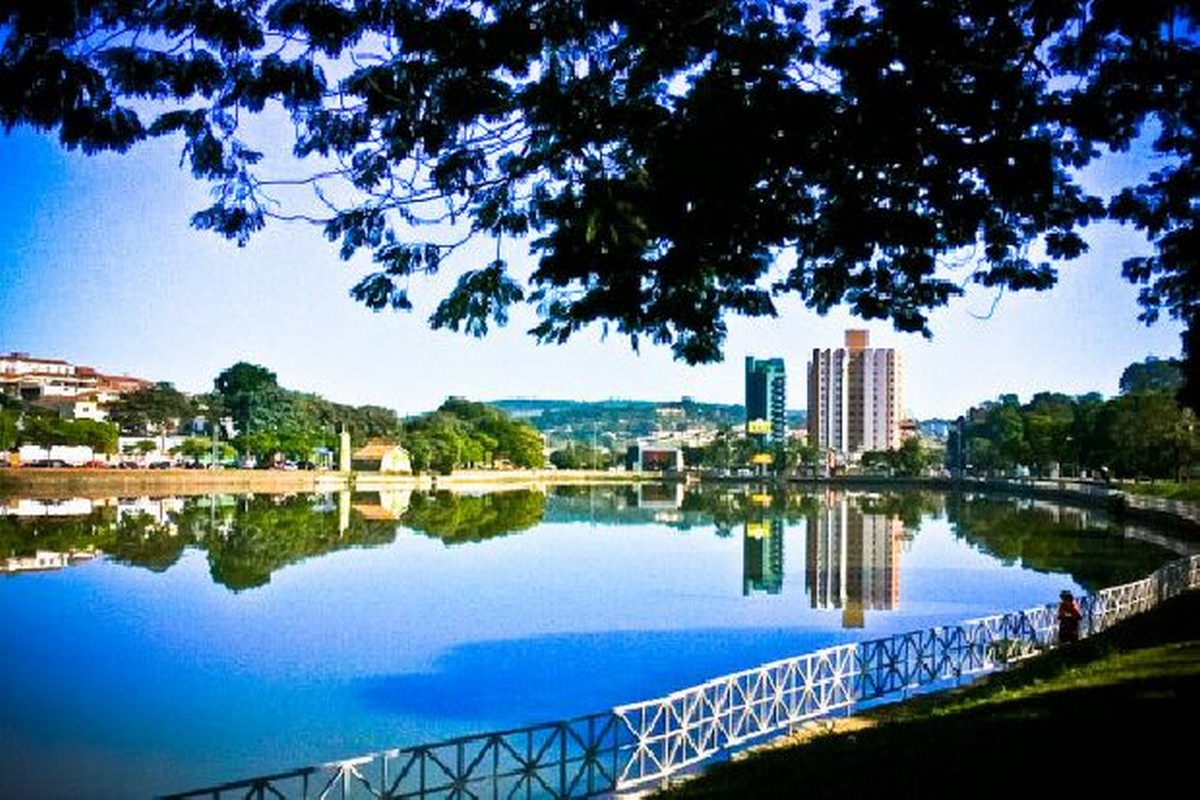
top-left (0, 485), bottom-right (1166, 590)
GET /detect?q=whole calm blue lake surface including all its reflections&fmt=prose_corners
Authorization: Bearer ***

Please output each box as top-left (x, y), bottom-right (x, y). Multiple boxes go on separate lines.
top-left (0, 486), bottom-right (1180, 799)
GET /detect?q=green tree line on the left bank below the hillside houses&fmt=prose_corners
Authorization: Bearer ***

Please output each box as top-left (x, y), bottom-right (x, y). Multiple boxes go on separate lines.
top-left (0, 362), bottom-right (544, 473)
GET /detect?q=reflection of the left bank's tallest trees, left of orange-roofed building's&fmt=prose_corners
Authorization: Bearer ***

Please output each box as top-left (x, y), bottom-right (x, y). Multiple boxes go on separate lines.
top-left (202, 495), bottom-right (396, 590)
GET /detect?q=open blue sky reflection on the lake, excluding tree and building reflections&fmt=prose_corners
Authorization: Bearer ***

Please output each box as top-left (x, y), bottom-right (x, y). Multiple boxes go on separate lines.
top-left (0, 496), bottom-right (1171, 798)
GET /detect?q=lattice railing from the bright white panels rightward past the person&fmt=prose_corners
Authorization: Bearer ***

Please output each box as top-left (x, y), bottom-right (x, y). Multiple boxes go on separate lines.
top-left (613, 555), bottom-right (1200, 792)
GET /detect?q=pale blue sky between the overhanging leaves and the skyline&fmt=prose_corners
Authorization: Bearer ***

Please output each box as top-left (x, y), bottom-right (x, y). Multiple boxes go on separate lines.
top-left (0, 124), bottom-right (1181, 419)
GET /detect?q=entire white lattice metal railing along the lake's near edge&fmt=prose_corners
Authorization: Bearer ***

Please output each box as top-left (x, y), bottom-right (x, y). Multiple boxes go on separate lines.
top-left (164, 555), bottom-right (1200, 800)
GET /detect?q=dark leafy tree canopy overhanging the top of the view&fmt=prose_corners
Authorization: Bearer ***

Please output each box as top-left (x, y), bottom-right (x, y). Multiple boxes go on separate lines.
top-left (0, 0), bottom-right (1200, 407)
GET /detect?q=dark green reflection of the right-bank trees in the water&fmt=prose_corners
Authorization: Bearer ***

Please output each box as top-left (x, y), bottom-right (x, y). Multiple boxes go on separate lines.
top-left (947, 495), bottom-right (1163, 590)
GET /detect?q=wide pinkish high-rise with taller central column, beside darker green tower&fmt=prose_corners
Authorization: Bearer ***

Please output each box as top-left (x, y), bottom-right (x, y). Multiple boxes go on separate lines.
top-left (808, 330), bottom-right (904, 456)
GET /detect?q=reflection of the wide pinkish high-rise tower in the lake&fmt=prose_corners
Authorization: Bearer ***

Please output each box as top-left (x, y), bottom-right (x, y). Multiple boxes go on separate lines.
top-left (805, 493), bottom-right (904, 627)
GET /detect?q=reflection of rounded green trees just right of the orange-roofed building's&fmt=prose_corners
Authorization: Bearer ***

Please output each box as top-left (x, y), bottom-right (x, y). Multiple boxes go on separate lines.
top-left (401, 489), bottom-right (546, 545)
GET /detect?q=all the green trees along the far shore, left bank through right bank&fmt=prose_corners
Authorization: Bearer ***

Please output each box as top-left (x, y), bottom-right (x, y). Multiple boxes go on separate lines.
top-left (7, 357), bottom-right (1200, 479)
